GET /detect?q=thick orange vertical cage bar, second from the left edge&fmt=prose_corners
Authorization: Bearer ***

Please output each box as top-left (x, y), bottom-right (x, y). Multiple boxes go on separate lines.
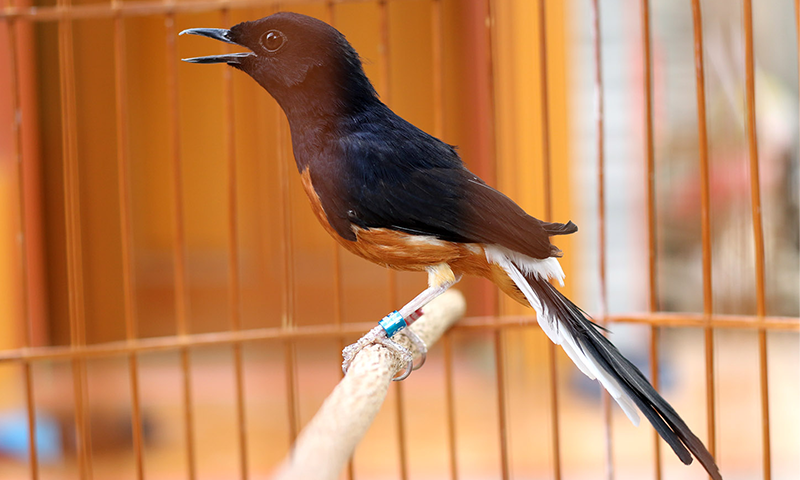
top-left (58, 0), bottom-right (92, 479)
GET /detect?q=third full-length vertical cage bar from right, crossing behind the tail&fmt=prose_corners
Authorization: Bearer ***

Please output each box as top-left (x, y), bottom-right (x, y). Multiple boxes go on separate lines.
top-left (641, 0), bottom-right (661, 480)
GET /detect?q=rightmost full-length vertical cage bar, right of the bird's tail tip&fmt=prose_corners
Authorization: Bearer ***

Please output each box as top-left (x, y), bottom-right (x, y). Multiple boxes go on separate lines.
top-left (743, 0), bottom-right (772, 480)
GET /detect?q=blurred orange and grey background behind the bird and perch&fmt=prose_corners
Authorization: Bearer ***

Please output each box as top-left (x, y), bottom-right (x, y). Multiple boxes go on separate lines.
top-left (0, 0), bottom-right (800, 479)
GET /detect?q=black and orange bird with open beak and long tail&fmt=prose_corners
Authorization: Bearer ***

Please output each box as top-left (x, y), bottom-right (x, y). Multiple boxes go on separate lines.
top-left (180, 12), bottom-right (722, 480)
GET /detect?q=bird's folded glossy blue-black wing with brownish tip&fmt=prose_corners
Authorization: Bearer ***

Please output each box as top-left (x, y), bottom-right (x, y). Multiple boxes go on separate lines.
top-left (311, 108), bottom-right (577, 258)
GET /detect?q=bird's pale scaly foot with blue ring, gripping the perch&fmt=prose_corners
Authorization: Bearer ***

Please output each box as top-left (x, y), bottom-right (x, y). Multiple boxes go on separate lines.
top-left (342, 309), bottom-right (428, 382)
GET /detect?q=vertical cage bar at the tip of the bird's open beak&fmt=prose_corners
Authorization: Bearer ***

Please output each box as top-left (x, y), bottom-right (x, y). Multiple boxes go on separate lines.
top-left (165, 9), bottom-right (197, 480)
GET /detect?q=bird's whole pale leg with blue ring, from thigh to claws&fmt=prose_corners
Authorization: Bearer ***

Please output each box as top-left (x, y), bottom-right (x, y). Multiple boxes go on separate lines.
top-left (342, 263), bottom-right (461, 381)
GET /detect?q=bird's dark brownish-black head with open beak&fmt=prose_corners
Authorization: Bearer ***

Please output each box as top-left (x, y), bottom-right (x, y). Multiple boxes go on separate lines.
top-left (180, 12), bottom-right (377, 115)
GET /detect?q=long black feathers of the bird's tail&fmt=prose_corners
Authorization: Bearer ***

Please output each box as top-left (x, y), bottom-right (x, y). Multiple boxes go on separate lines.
top-left (527, 276), bottom-right (722, 480)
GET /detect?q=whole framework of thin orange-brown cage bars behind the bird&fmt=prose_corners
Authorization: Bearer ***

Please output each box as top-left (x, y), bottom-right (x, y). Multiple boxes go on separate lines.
top-left (0, 0), bottom-right (800, 480)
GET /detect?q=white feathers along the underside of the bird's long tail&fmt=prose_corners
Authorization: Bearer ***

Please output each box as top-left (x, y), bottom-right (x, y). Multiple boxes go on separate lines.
top-left (485, 245), bottom-right (639, 426)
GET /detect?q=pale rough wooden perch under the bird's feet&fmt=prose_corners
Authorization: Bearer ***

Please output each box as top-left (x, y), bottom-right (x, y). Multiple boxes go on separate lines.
top-left (273, 290), bottom-right (466, 480)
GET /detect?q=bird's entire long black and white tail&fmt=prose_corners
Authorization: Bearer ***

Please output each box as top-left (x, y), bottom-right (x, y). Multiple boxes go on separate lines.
top-left (487, 248), bottom-right (722, 480)
